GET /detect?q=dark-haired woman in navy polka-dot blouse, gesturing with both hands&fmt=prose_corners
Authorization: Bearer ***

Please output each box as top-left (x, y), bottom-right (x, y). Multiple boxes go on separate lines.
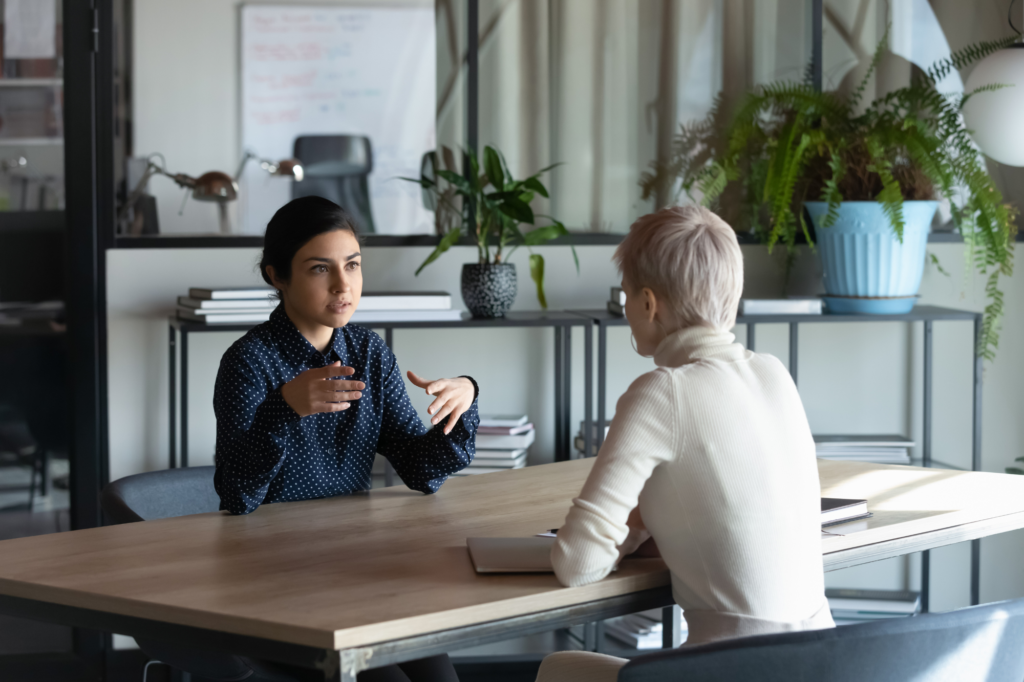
top-left (213, 197), bottom-right (479, 682)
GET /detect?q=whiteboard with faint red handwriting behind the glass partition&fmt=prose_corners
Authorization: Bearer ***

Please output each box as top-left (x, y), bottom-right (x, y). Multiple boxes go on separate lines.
top-left (240, 4), bottom-right (437, 235)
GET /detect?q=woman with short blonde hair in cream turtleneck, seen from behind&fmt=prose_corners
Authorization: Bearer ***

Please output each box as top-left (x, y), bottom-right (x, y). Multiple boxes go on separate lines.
top-left (538, 206), bottom-right (834, 682)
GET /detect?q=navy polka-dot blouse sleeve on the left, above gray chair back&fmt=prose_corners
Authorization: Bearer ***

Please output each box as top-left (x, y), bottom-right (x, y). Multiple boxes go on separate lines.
top-left (213, 351), bottom-right (301, 514)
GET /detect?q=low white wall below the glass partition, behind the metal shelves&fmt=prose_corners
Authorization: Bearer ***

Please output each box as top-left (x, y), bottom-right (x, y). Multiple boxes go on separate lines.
top-left (108, 237), bottom-right (1024, 608)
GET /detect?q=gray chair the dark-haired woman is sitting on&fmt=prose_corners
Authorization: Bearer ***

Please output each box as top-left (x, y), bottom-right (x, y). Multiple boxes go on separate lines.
top-left (100, 467), bottom-right (315, 682)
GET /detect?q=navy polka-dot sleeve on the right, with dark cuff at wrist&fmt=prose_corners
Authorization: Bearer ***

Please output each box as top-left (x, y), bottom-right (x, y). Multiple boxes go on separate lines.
top-left (377, 352), bottom-right (480, 494)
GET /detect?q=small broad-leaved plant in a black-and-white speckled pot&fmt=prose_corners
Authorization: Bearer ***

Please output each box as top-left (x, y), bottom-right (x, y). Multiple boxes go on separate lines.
top-left (402, 145), bottom-right (580, 317)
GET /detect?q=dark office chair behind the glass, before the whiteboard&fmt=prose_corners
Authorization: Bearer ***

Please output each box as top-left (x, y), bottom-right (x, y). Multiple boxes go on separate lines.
top-left (292, 135), bottom-right (377, 233)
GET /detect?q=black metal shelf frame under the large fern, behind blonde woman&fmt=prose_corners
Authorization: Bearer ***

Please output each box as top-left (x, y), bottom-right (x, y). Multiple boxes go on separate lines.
top-left (572, 305), bottom-right (984, 611)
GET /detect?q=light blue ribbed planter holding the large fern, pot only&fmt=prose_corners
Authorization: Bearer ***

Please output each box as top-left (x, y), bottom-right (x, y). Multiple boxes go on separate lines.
top-left (805, 197), bottom-right (938, 314)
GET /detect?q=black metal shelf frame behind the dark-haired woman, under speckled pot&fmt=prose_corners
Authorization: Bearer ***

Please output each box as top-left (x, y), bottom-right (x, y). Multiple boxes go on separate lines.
top-left (168, 310), bottom-right (593, 466)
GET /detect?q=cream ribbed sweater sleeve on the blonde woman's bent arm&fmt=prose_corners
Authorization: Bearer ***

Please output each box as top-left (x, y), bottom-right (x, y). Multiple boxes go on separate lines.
top-left (551, 369), bottom-right (679, 587)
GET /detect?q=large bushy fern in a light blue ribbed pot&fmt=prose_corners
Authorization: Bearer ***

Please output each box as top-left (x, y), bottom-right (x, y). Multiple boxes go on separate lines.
top-left (641, 34), bottom-right (1017, 358)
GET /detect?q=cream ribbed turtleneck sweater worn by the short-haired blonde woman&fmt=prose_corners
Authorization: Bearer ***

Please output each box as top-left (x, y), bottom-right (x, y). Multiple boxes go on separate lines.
top-left (551, 328), bottom-right (834, 644)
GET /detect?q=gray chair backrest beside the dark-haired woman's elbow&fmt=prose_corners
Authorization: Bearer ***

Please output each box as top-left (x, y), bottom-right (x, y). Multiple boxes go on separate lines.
top-left (100, 467), bottom-right (220, 523)
